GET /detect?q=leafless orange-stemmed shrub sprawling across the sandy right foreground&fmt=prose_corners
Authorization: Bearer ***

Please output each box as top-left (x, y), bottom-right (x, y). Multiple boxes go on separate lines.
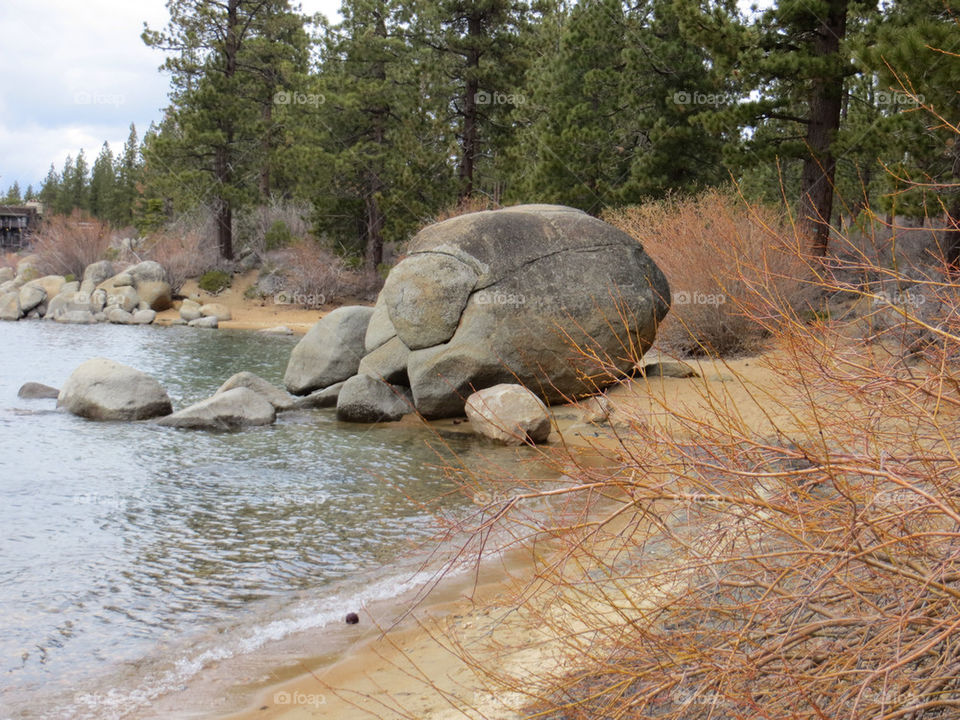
top-left (422, 202), bottom-right (960, 720)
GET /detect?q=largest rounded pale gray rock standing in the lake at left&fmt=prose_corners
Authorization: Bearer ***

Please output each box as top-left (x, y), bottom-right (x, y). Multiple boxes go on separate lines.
top-left (57, 358), bottom-right (173, 420)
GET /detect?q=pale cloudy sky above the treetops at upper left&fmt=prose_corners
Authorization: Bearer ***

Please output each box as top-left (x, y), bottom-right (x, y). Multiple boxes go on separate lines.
top-left (0, 0), bottom-right (340, 196)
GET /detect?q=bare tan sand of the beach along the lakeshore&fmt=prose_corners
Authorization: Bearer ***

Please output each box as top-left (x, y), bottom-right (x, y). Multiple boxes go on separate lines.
top-left (125, 298), bottom-right (786, 720)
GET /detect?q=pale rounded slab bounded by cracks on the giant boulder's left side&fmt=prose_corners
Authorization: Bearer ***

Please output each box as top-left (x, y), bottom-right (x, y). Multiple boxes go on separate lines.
top-left (381, 251), bottom-right (478, 350)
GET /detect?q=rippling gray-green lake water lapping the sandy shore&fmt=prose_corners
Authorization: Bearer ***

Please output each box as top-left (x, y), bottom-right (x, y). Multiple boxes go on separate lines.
top-left (0, 321), bottom-right (540, 719)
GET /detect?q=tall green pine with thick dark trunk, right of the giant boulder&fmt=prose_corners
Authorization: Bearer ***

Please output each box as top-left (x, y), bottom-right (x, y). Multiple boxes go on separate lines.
top-left (677, 0), bottom-right (875, 255)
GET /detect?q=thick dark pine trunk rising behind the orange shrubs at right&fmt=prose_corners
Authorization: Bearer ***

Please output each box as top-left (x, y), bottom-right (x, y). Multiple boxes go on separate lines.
top-left (799, 0), bottom-right (849, 256)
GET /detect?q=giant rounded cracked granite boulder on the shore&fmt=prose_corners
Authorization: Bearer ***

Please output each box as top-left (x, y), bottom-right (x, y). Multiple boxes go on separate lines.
top-left (342, 205), bottom-right (670, 418)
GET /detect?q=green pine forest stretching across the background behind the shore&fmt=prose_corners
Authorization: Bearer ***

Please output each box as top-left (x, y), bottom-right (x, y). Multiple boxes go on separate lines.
top-left (8, 0), bottom-right (960, 266)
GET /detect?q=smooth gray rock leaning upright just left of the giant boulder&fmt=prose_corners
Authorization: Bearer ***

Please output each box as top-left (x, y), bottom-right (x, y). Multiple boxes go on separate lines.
top-left (283, 306), bottom-right (373, 395)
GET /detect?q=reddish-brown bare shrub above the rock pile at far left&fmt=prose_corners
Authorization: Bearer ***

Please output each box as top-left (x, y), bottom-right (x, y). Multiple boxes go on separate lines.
top-left (32, 210), bottom-right (111, 278)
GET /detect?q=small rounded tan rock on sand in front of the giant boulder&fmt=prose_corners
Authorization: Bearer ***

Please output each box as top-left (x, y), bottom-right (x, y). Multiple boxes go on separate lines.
top-left (464, 383), bottom-right (550, 445)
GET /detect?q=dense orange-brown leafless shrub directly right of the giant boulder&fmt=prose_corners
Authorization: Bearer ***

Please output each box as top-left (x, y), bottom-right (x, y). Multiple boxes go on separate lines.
top-left (603, 190), bottom-right (810, 355)
